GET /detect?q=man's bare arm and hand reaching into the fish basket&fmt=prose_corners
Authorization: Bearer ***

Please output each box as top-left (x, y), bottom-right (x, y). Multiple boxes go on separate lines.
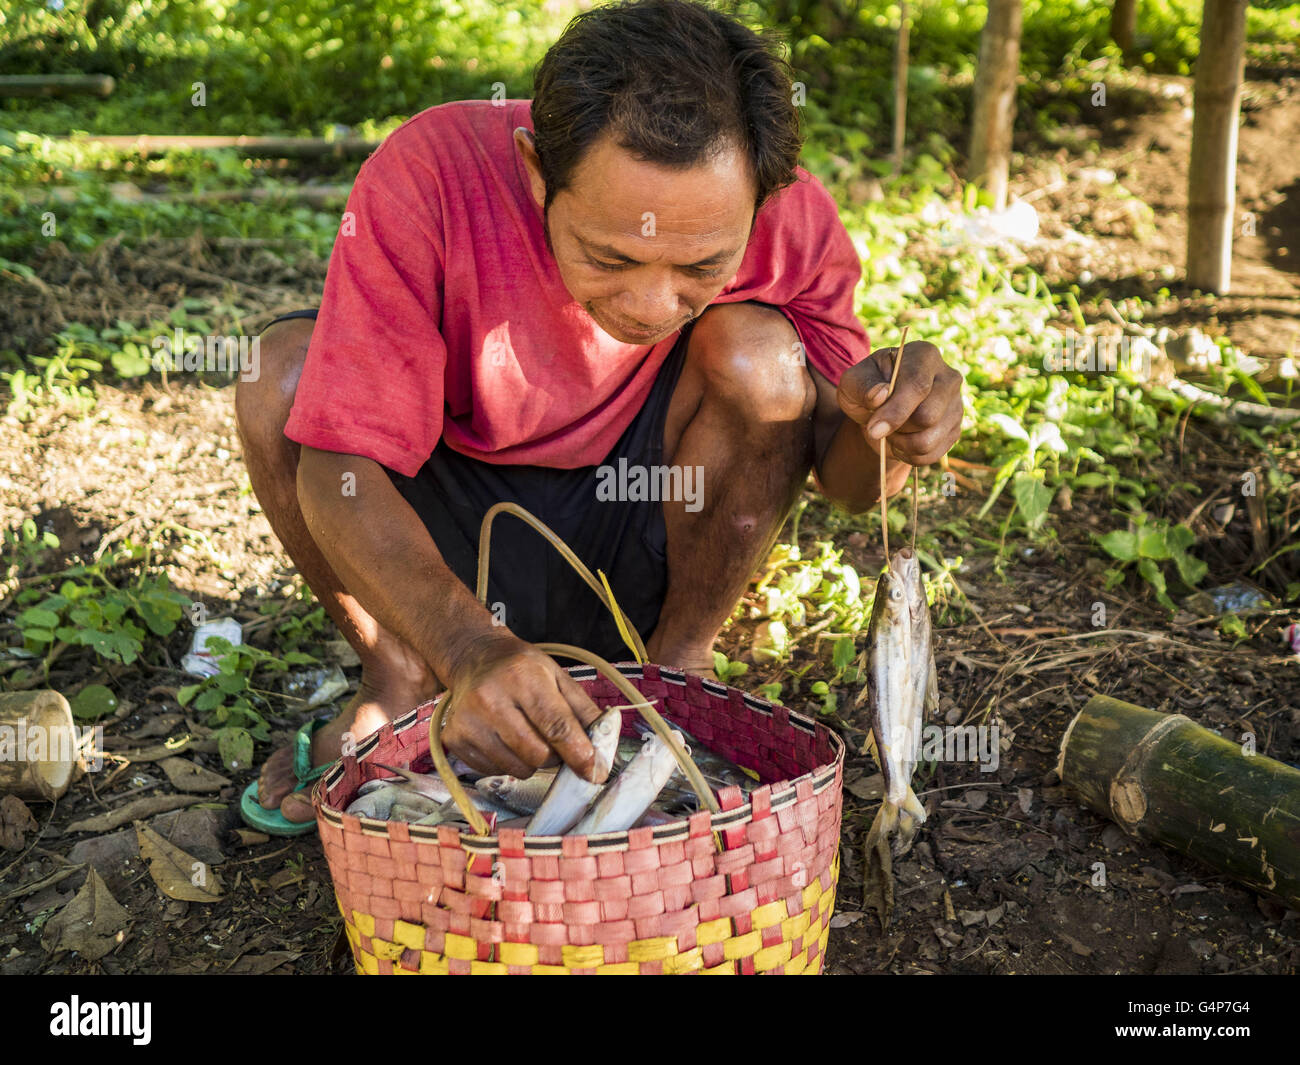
top-left (298, 446), bottom-right (599, 778)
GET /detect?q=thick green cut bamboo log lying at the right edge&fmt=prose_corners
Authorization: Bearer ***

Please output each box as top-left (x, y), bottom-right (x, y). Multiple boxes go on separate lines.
top-left (1057, 696), bottom-right (1300, 908)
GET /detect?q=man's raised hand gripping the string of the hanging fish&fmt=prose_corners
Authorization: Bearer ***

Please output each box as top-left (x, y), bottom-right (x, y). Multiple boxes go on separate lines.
top-left (836, 341), bottom-right (962, 466)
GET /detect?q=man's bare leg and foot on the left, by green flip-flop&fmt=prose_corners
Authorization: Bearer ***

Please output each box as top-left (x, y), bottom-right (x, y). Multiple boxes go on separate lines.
top-left (235, 319), bottom-right (441, 821)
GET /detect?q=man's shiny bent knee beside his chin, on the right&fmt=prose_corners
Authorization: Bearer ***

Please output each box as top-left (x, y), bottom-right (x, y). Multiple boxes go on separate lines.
top-left (688, 303), bottom-right (816, 421)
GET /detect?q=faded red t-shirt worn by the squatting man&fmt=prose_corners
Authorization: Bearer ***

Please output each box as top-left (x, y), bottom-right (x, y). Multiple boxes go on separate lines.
top-left (285, 100), bottom-right (870, 476)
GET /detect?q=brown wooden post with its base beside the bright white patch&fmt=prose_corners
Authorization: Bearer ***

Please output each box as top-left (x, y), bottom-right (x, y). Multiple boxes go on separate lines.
top-left (971, 0), bottom-right (1022, 209)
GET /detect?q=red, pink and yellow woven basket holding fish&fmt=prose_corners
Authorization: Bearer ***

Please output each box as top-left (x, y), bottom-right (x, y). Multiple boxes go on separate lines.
top-left (312, 664), bottom-right (844, 974)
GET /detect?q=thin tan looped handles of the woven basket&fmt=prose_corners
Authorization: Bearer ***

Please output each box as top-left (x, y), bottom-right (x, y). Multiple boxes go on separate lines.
top-left (429, 503), bottom-right (720, 836)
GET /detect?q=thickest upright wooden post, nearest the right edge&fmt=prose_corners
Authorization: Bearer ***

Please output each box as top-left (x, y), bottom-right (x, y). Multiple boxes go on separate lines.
top-left (1187, 0), bottom-right (1247, 295)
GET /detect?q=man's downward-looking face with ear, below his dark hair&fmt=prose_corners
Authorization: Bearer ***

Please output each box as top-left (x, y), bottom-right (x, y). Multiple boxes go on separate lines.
top-left (520, 128), bottom-right (757, 345)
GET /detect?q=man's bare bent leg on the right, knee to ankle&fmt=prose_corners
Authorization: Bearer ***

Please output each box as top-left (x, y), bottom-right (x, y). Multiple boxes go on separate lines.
top-left (646, 303), bottom-right (816, 675)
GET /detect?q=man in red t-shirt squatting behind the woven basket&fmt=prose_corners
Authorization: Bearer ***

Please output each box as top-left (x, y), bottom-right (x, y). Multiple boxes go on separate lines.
top-left (237, 0), bottom-right (962, 823)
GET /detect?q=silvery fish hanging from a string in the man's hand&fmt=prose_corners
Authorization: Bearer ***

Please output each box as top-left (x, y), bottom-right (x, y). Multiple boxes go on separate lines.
top-left (855, 547), bottom-right (939, 927)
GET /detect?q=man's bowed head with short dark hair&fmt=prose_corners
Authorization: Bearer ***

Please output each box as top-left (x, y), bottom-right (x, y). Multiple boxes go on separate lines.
top-left (516, 0), bottom-right (801, 345)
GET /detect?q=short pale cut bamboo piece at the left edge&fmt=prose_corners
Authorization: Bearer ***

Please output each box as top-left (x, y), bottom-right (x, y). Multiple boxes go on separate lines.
top-left (0, 690), bottom-right (77, 801)
